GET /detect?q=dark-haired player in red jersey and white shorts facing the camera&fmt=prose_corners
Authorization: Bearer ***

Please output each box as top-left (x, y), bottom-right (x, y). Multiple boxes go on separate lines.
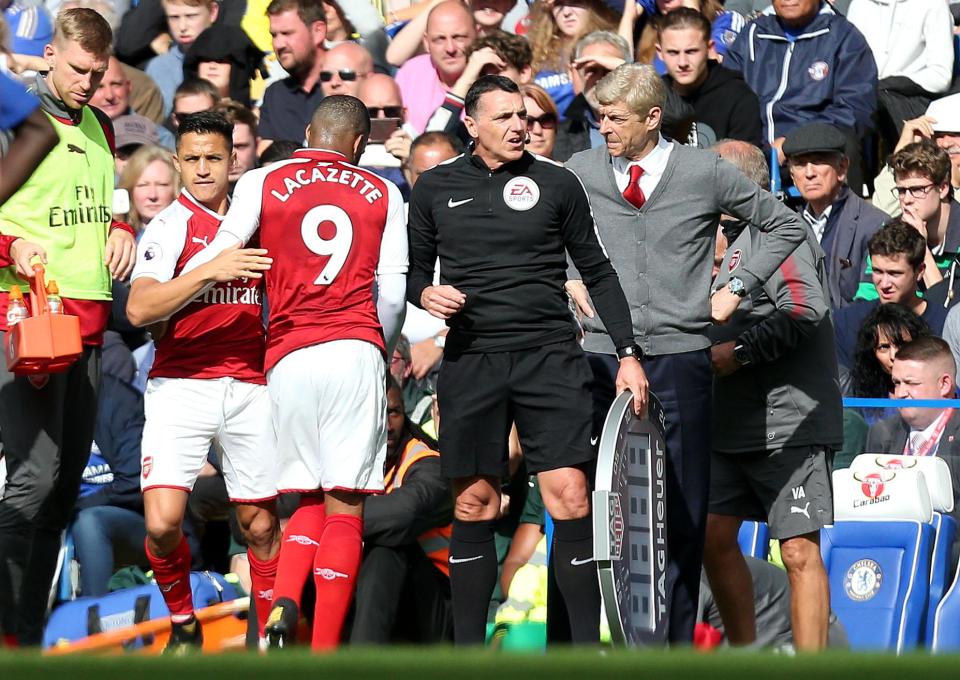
top-left (127, 112), bottom-right (280, 650)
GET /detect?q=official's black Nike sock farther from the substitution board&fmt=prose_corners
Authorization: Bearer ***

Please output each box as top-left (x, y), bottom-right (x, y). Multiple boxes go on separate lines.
top-left (449, 519), bottom-right (497, 645)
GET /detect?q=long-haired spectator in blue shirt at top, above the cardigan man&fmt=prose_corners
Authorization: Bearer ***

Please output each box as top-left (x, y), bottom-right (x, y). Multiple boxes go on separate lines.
top-left (527, 0), bottom-right (616, 120)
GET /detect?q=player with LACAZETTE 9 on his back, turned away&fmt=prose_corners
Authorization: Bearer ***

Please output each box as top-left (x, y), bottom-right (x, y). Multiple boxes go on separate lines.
top-left (188, 95), bottom-right (407, 649)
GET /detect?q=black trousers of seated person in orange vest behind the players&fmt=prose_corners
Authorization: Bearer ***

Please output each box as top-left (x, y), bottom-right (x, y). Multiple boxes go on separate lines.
top-left (350, 544), bottom-right (453, 645)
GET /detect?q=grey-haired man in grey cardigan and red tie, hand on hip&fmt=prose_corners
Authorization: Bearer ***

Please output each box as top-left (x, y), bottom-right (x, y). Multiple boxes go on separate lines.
top-left (567, 64), bottom-right (808, 644)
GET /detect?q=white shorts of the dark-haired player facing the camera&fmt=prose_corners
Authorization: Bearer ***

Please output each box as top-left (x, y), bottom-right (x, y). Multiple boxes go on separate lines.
top-left (140, 378), bottom-right (277, 503)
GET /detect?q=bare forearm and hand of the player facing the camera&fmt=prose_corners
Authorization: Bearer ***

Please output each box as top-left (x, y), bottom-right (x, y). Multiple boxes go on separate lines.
top-left (127, 245), bottom-right (273, 326)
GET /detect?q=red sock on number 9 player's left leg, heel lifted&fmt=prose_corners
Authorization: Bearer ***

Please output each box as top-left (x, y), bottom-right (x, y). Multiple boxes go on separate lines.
top-left (273, 496), bottom-right (326, 607)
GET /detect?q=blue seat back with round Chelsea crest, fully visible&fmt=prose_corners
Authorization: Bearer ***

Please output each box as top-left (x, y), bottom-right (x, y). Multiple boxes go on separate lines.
top-left (820, 521), bottom-right (934, 653)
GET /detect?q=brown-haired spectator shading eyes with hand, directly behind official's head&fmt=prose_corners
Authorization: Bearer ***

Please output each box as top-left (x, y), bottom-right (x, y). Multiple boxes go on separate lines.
top-left (426, 31), bottom-right (533, 144)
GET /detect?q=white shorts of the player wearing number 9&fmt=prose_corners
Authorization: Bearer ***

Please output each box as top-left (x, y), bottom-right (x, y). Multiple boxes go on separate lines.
top-left (267, 340), bottom-right (387, 493)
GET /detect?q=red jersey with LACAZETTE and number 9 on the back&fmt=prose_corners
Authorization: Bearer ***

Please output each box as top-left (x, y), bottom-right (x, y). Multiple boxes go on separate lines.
top-left (224, 149), bottom-right (406, 370)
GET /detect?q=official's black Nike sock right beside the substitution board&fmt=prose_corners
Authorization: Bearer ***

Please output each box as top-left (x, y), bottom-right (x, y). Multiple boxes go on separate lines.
top-left (548, 515), bottom-right (600, 645)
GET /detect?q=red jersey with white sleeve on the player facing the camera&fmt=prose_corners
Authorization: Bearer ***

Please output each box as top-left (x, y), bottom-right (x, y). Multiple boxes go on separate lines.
top-left (133, 190), bottom-right (266, 384)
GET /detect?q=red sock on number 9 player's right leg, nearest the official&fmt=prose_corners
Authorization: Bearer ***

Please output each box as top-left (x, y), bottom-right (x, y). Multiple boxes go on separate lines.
top-left (311, 515), bottom-right (363, 650)
